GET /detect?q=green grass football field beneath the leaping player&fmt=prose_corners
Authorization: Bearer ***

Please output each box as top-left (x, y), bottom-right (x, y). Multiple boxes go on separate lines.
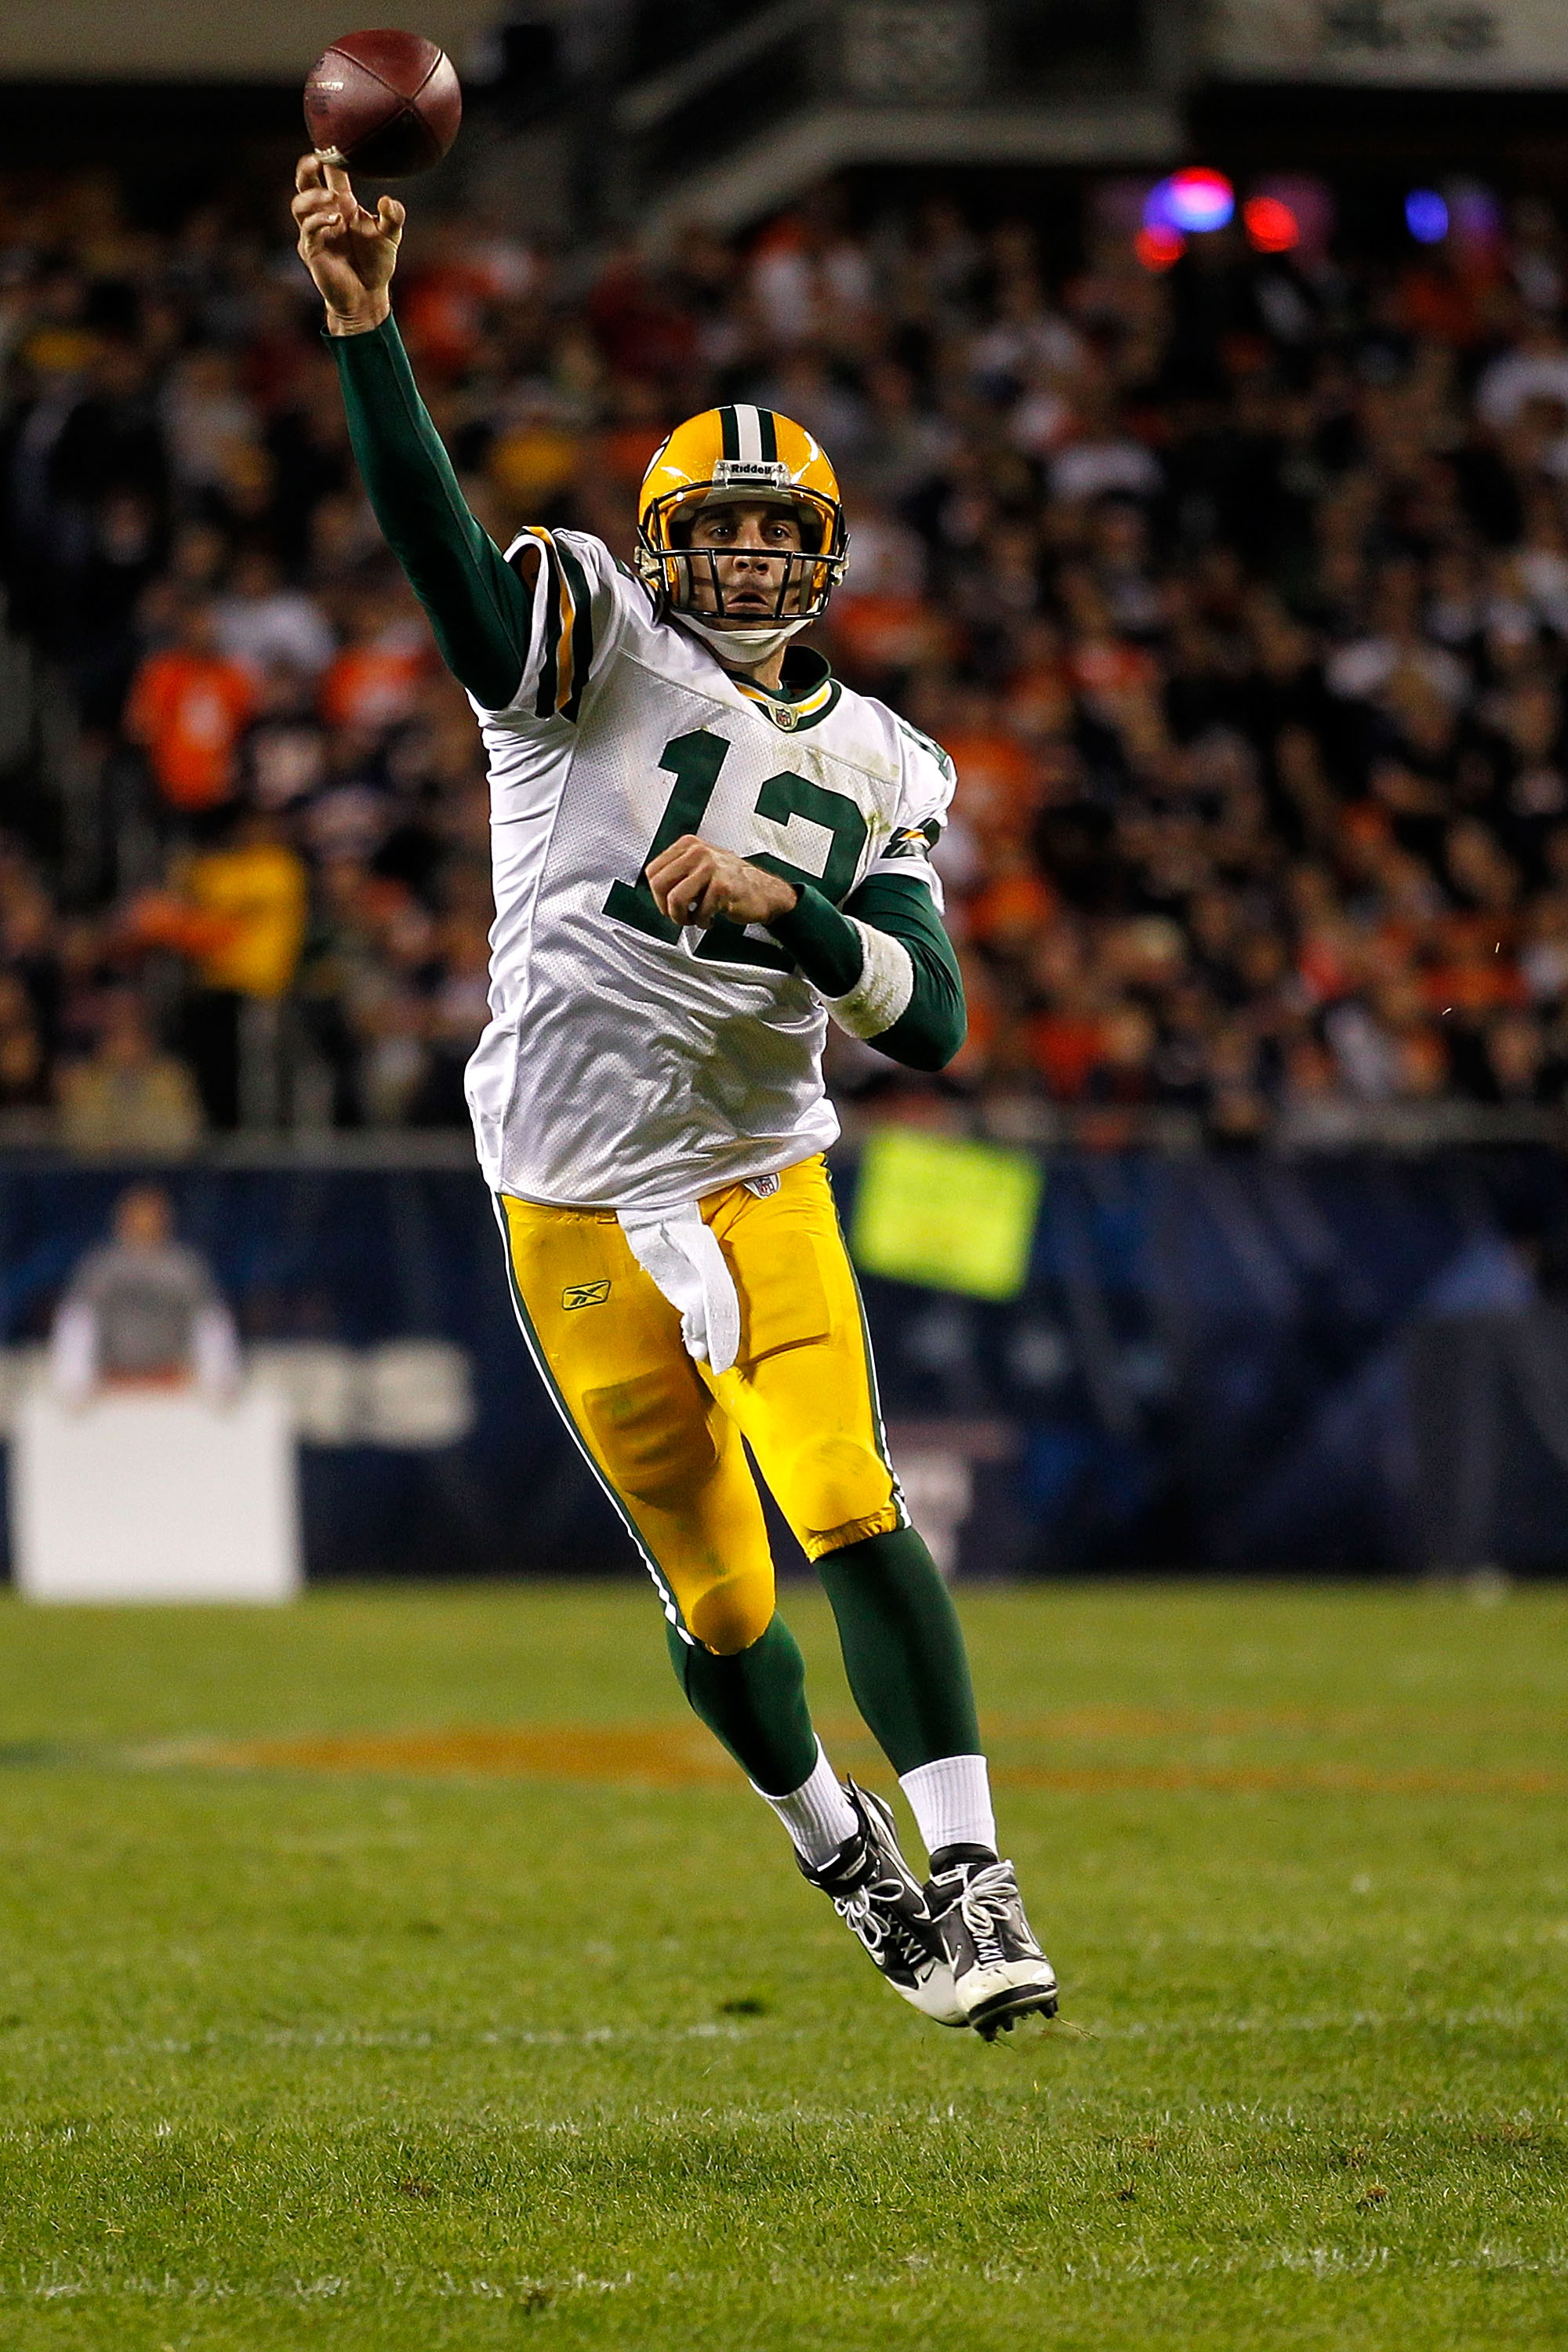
top-left (0, 1585), bottom-right (1568, 2352)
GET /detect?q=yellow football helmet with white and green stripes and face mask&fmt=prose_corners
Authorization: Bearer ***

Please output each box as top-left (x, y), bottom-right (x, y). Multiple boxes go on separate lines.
top-left (637, 402), bottom-right (848, 628)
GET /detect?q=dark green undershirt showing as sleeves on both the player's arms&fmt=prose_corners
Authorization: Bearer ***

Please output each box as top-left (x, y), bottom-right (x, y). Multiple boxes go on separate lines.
top-left (327, 318), bottom-right (964, 1070)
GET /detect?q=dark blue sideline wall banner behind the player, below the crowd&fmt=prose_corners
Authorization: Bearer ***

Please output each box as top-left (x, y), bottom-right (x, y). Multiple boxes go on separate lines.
top-left (0, 1148), bottom-right (1568, 1581)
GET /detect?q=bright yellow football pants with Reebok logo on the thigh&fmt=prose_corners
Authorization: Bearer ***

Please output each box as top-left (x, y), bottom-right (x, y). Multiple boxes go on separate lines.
top-left (501, 1155), bottom-right (907, 1656)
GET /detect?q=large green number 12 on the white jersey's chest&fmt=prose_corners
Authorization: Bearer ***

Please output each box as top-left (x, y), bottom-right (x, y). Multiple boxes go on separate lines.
top-left (604, 727), bottom-right (865, 971)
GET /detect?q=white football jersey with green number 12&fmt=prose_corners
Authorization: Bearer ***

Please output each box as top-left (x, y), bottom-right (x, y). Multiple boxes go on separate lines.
top-left (466, 529), bottom-right (952, 1214)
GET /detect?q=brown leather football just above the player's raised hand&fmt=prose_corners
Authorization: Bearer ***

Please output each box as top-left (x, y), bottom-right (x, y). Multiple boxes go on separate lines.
top-left (306, 33), bottom-right (463, 179)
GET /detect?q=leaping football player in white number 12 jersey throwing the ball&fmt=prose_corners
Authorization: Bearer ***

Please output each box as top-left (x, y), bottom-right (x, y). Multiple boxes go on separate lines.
top-left (294, 155), bottom-right (1055, 2037)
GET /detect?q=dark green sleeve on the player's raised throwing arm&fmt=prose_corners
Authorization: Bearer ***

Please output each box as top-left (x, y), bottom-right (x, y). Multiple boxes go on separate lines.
top-left (332, 318), bottom-right (529, 710)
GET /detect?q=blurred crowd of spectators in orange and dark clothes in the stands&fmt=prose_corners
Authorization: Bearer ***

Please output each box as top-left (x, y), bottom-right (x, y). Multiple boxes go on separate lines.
top-left (0, 158), bottom-right (1568, 1148)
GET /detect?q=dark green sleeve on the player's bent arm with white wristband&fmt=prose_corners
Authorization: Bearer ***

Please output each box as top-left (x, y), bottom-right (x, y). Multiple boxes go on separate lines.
top-left (769, 875), bottom-right (966, 1070)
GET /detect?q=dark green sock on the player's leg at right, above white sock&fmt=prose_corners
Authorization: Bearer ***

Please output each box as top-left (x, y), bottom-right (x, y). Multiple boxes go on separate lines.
top-left (815, 1526), bottom-right (980, 1773)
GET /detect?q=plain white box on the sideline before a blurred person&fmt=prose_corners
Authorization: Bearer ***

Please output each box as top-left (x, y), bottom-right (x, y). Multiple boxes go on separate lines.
top-left (9, 1383), bottom-right (301, 1602)
